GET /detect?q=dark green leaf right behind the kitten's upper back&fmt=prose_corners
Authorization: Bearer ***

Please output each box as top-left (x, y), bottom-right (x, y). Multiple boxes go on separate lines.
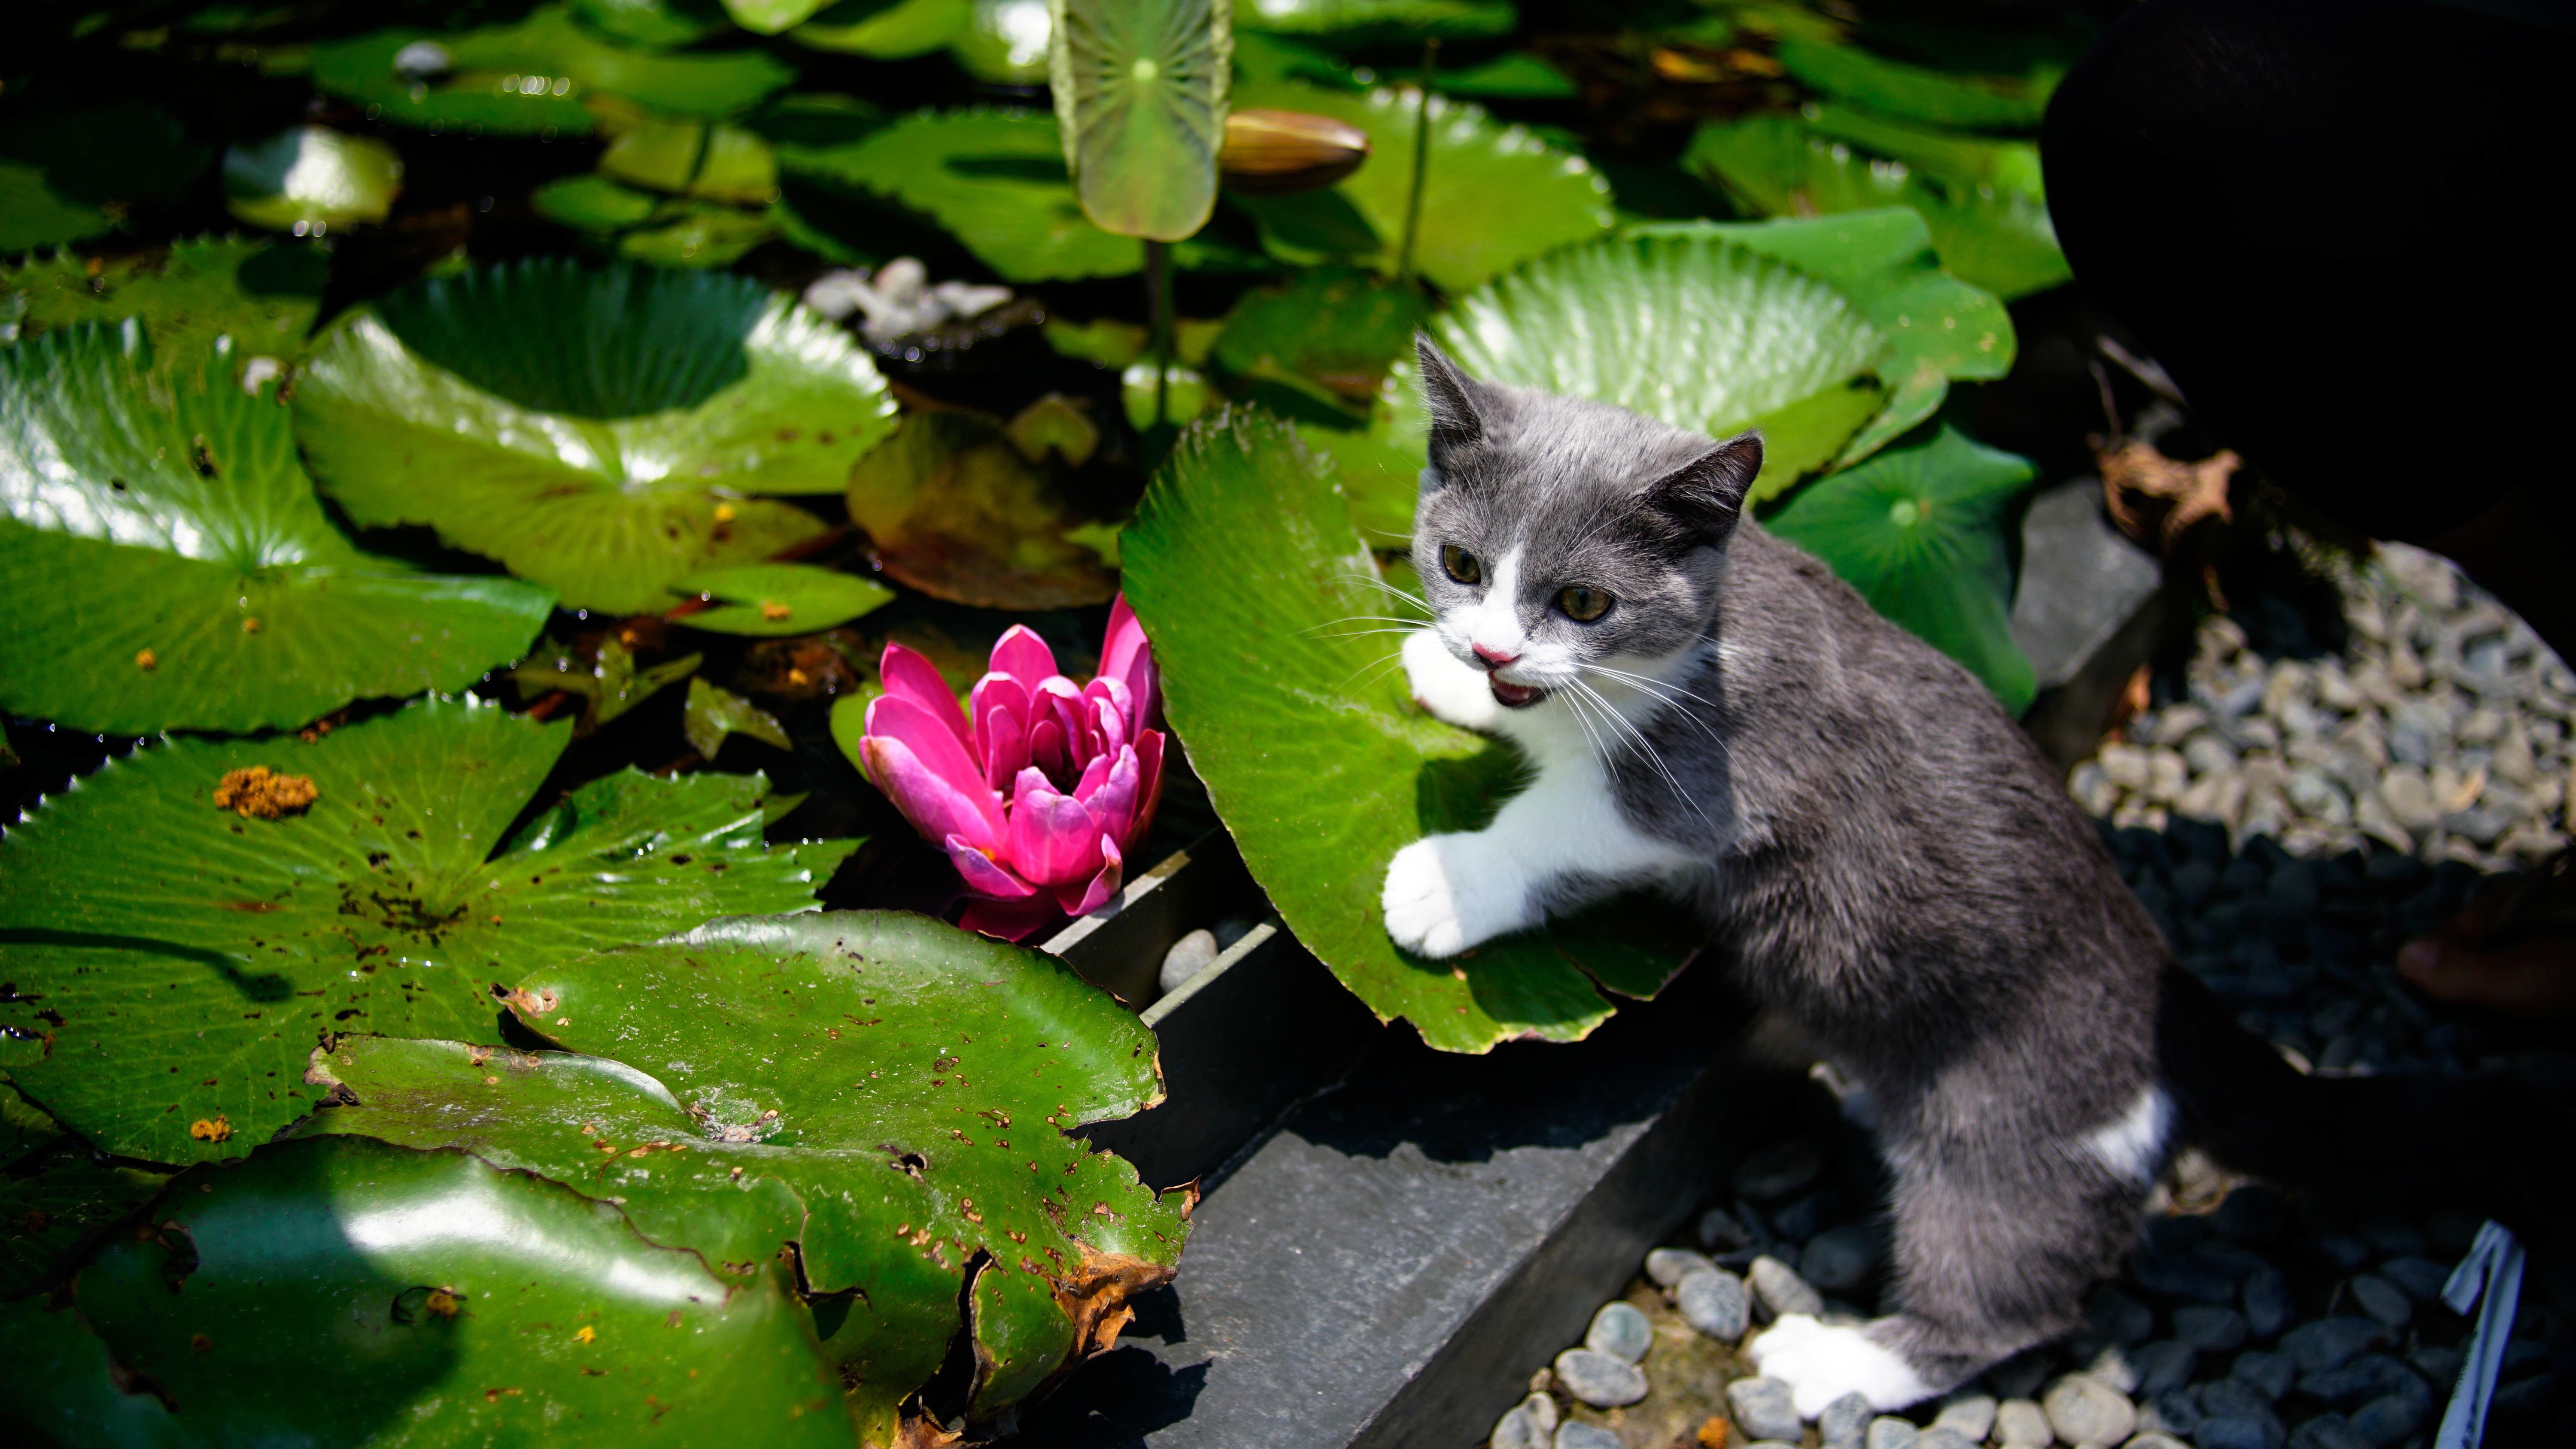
top-left (1770, 422), bottom-right (2038, 715)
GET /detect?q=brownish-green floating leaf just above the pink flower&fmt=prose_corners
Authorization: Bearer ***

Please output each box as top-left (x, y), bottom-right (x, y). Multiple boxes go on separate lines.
top-left (850, 412), bottom-right (1118, 610)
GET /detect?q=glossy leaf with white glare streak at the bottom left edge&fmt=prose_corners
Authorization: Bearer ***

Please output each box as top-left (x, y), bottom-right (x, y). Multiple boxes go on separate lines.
top-left (75, 1137), bottom-right (855, 1449)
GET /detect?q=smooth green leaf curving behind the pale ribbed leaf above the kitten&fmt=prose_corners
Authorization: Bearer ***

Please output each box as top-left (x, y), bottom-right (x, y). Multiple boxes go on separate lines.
top-left (1631, 206), bottom-right (2017, 466)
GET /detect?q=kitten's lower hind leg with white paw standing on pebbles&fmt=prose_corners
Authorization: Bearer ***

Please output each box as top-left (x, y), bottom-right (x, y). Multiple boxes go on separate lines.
top-left (1747, 1132), bottom-right (2154, 1418)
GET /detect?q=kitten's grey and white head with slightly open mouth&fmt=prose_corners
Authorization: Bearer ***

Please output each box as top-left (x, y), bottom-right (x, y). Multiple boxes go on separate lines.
top-left (1414, 335), bottom-right (1762, 708)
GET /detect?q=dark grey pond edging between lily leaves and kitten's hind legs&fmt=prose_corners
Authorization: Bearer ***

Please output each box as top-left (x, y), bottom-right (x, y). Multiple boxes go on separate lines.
top-left (1015, 831), bottom-right (1795, 1449)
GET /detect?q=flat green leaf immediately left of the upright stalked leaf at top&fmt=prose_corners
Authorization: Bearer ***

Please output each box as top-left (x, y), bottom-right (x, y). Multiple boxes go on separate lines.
top-left (778, 109), bottom-right (1144, 283)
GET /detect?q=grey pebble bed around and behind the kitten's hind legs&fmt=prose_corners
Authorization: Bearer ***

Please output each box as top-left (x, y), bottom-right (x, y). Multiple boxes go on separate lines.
top-left (1486, 548), bottom-right (2576, 1449)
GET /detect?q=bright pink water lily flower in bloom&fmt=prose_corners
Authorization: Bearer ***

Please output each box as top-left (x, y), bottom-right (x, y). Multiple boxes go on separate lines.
top-left (860, 594), bottom-right (1162, 940)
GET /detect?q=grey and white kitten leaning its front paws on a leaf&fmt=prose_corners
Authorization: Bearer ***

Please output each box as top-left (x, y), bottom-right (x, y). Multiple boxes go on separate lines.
top-left (1383, 340), bottom-right (2483, 1416)
